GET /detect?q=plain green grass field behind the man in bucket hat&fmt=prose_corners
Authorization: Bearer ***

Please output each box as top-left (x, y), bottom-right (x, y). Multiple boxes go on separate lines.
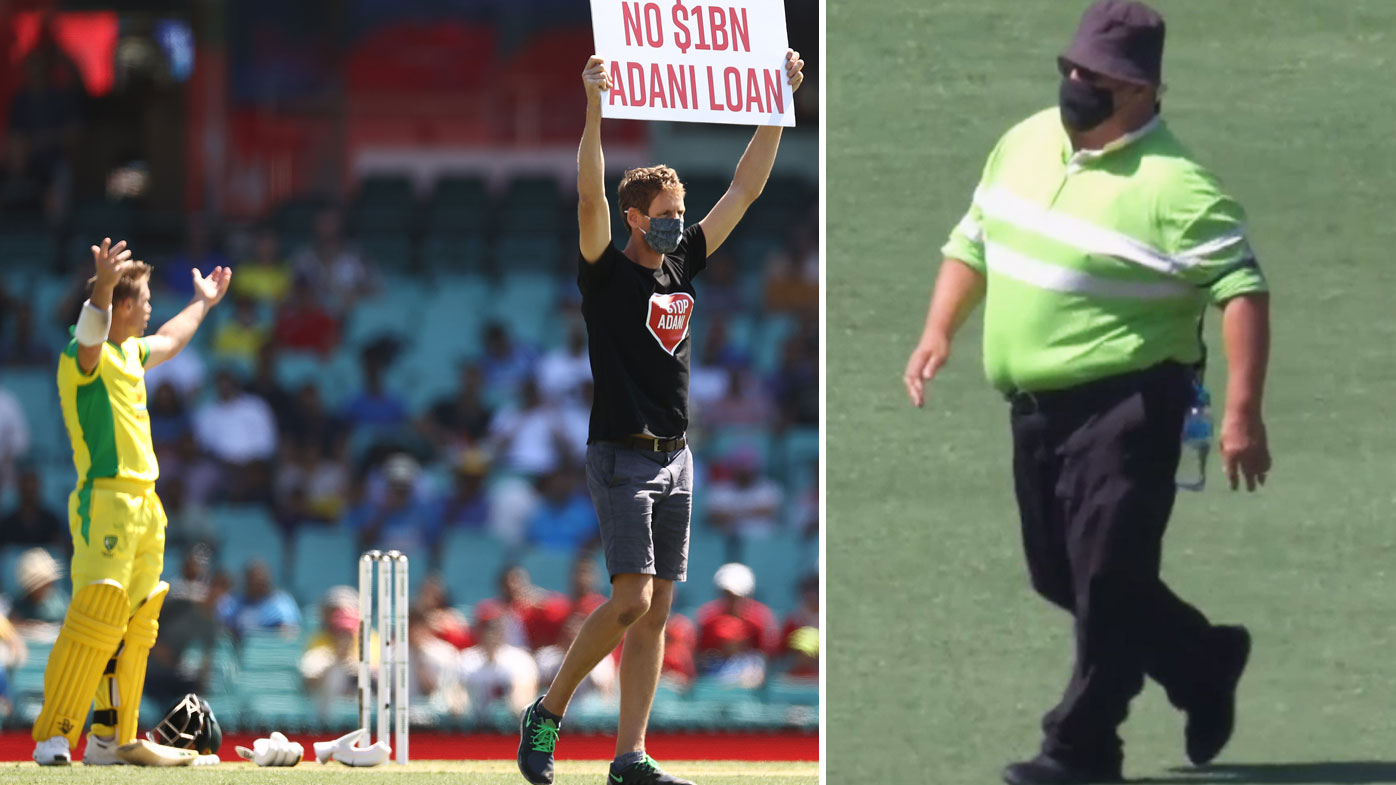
top-left (826, 0), bottom-right (1396, 784)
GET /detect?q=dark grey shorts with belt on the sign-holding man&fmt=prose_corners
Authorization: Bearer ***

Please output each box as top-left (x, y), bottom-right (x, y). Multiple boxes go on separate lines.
top-left (586, 441), bottom-right (694, 581)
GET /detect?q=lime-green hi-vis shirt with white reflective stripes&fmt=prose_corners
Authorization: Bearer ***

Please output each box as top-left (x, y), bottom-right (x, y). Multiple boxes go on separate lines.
top-left (942, 108), bottom-right (1266, 391)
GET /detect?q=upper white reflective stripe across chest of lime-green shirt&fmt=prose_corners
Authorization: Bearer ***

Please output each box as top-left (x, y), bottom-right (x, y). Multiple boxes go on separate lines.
top-left (979, 189), bottom-right (1198, 275)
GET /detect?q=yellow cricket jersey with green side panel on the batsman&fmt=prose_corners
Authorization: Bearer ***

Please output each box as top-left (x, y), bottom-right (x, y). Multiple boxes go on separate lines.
top-left (59, 338), bottom-right (159, 492)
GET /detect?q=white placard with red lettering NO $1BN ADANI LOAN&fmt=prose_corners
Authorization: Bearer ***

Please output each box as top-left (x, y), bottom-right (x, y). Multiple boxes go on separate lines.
top-left (592, 0), bottom-right (794, 126)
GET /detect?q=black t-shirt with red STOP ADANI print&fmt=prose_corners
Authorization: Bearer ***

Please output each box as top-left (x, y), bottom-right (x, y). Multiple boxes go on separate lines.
top-left (577, 223), bottom-right (708, 441)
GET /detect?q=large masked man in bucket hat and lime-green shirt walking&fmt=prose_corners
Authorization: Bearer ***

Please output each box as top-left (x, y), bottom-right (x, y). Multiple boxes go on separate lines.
top-left (905, 0), bottom-right (1270, 785)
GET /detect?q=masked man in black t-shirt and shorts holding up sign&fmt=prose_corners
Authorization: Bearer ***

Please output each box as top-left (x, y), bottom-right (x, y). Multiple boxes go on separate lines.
top-left (518, 50), bottom-right (804, 785)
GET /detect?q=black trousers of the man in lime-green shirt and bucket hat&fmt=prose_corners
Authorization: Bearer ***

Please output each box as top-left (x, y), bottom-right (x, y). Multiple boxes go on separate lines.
top-left (1009, 363), bottom-right (1212, 765)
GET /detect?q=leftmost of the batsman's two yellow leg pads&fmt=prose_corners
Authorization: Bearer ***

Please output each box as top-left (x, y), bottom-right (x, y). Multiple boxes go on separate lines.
top-left (34, 581), bottom-right (131, 747)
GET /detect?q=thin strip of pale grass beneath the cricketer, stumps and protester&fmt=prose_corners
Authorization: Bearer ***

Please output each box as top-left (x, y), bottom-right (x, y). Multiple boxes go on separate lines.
top-left (0, 760), bottom-right (819, 785)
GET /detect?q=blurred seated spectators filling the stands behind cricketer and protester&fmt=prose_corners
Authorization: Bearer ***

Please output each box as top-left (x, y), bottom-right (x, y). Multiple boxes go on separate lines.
top-left (0, 191), bottom-right (818, 715)
